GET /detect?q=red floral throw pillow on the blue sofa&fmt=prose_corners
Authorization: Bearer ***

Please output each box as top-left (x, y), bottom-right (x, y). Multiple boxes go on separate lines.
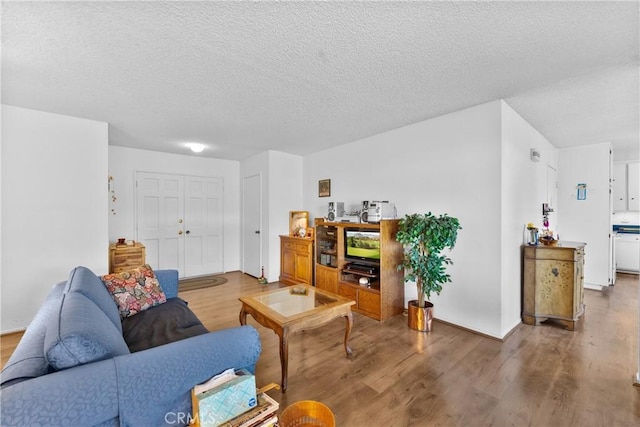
top-left (100, 264), bottom-right (167, 319)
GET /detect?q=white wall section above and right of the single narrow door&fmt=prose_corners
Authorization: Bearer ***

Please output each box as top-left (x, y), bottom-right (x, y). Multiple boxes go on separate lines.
top-left (240, 151), bottom-right (306, 282)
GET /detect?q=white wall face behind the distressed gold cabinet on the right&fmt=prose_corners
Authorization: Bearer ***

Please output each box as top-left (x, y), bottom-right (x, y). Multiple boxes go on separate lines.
top-left (500, 102), bottom-right (558, 336)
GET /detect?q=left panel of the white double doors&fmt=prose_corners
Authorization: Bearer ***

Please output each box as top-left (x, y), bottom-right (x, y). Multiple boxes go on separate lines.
top-left (136, 172), bottom-right (184, 271)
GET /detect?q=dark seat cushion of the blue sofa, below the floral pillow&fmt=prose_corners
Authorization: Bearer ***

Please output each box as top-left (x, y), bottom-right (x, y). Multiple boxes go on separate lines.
top-left (122, 298), bottom-right (209, 352)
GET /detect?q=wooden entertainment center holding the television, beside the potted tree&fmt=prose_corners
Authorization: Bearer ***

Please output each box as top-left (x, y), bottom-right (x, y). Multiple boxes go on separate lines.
top-left (315, 219), bottom-right (404, 321)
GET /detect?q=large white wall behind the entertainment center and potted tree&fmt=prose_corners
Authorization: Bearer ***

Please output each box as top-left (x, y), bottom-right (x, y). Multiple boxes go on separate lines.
top-left (304, 101), bottom-right (508, 337)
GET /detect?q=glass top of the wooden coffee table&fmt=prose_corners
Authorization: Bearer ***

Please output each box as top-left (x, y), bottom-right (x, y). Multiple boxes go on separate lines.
top-left (252, 285), bottom-right (338, 317)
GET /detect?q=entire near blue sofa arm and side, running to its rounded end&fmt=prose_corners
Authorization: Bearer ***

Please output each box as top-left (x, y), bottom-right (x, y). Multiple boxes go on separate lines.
top-left (0, 326), bottom-right (260, 426)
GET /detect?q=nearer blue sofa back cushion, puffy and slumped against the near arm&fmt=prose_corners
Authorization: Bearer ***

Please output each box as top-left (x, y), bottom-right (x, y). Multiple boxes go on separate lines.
top-left (44, 292), bottom-right (129, 370)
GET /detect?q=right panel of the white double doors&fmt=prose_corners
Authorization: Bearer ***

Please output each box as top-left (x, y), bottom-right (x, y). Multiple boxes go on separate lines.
top-left (184, 177), bottom-right (224, 276)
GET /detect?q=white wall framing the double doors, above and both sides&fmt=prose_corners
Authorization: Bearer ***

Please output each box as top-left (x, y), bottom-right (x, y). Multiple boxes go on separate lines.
top-left (109, 146), bottom-right (241, 271)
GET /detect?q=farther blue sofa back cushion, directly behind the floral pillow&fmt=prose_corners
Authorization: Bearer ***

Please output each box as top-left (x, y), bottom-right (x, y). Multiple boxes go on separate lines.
top-left (65, 266), bottom-right (122, 332)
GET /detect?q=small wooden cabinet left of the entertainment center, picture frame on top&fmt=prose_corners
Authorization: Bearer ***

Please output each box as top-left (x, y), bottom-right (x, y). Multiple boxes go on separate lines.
top-left (280, 236), bottom-right (313, 285)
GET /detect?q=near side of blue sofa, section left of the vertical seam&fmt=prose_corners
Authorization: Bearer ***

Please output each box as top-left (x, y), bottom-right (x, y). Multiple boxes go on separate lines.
top-left (1, 359), bottom-right (118, 426)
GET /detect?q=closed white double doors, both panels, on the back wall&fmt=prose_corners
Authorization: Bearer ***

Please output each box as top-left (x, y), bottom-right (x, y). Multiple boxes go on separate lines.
top-left (136, 172), bottom-right (224, 277)
